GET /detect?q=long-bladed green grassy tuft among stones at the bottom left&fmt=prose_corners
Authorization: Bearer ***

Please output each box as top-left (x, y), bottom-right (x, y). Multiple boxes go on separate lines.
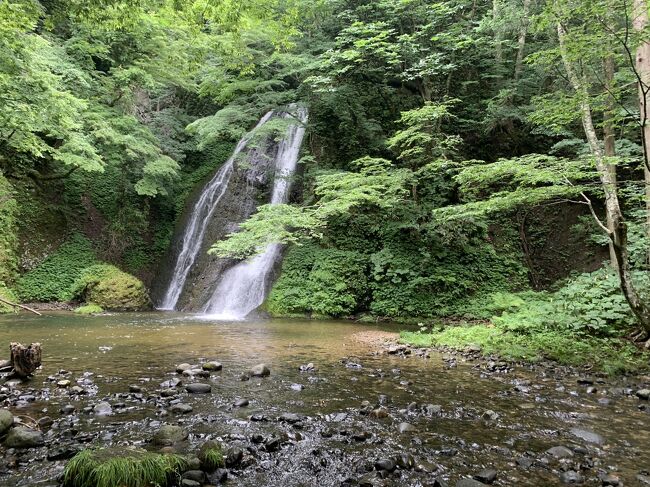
top-left (63, 449), bottom-right (187, 487)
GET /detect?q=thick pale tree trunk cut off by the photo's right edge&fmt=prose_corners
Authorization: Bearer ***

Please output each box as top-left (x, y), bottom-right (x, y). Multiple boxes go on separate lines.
top-left (632, 0), bottom-right (650, 260)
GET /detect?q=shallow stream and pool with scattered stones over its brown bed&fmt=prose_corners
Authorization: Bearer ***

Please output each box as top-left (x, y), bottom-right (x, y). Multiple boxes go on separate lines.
top-left (0, 313), bottom-right (650, 487)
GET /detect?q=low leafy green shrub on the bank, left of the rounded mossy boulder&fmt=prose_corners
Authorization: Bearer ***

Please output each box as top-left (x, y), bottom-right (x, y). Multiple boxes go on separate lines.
top-left (16, 234), bottom-right (97, 302)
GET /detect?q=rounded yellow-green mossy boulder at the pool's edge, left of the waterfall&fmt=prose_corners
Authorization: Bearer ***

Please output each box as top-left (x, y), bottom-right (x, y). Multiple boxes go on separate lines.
top-left (75, 264), bottom-right (151, 311)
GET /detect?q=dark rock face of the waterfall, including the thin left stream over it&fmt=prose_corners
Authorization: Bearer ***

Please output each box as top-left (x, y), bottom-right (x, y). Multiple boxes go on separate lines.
top-left (152, 109), bottom-right (306, 312)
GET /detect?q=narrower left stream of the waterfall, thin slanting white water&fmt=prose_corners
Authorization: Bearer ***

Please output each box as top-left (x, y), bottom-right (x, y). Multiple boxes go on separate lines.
top-left (159, 111), bottom-right (273, 310)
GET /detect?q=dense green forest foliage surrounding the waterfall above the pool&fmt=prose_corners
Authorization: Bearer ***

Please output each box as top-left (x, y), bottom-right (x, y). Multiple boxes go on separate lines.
top-left (0, 0), bottom-right (650, 368)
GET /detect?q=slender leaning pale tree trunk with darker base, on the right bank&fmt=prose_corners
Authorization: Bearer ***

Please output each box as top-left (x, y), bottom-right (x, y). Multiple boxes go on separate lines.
top-left (557, 22), bottom-right (650, 333)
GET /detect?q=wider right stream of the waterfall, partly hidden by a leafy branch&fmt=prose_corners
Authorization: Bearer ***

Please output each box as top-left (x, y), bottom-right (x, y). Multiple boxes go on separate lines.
top-left (203, 108), bottom-right (307, 320)
